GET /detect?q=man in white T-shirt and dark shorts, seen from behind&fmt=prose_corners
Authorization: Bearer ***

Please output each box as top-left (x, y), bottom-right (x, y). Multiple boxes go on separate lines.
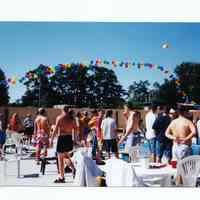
top-left (101, 110), bottom-right (118, 158)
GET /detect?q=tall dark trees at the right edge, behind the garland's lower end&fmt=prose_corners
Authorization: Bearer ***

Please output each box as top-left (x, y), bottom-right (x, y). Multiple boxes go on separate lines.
top-left (154, 62), bottom-right (200, 107)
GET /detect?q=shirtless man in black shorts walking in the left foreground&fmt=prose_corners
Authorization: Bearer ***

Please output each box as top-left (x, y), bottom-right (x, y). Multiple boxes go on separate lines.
top-left (50, 106), bottom-right (76, 183)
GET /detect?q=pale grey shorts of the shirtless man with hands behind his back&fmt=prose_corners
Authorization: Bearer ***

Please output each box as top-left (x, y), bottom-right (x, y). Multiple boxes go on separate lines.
top-left (173, 144), bottom-right (192, 160)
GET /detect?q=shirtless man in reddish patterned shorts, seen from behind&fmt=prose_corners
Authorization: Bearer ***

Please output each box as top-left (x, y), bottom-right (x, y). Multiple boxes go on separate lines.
top-left (33, 108), bottom-right (50, 164)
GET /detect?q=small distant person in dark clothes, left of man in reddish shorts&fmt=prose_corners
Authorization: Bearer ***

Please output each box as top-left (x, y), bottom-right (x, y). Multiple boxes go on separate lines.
top-left (24, 114), bottom-right (34, 144)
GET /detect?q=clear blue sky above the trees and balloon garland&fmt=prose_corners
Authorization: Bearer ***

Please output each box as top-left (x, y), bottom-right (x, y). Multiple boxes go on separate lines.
top-left (0, 22), bottom-right (200, 102)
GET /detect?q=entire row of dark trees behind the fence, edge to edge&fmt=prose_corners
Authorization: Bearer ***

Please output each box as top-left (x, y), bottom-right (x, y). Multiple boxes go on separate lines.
top-left (0, 63), bottom-right (200, 108)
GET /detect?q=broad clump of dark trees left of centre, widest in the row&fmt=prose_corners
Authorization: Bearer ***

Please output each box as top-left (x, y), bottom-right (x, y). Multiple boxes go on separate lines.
top-left (22, 64), bottom-right (125, 108)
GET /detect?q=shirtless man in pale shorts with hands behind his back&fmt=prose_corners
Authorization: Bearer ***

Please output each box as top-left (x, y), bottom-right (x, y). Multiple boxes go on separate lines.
top-left (165, 107), bottom-right (196, 160)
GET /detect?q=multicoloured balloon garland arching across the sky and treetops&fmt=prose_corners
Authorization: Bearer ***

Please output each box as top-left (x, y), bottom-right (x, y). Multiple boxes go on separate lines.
top-left (0, 58), bottom-right (184, 96)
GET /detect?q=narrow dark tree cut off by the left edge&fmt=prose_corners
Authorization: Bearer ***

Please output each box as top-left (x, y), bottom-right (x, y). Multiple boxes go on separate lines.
top-left (0, 69), bottom-right (10, 106)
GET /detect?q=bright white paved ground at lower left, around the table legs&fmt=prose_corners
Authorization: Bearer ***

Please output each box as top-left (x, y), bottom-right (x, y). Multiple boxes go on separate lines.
top-left (0, 156), bottom-right (73, 187)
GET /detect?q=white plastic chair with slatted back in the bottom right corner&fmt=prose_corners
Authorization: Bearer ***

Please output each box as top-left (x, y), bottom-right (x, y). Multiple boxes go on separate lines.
top-left (177, 155), bottom-right (200, 187)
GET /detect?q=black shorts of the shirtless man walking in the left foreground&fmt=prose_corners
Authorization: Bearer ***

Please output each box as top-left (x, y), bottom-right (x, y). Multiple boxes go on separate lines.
top-left (56, 135), bottom-right (73, 153)
